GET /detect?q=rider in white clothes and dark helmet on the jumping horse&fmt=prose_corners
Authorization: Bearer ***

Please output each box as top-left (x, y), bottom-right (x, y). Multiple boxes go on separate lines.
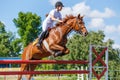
top-left (37, 1), bottom-right (64, 47)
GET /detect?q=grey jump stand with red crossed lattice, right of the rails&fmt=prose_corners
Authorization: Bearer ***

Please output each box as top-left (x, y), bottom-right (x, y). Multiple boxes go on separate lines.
top-left (89, 45), bottom-right (108, 80)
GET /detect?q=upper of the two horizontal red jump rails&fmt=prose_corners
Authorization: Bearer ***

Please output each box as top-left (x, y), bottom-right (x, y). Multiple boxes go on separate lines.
top-left (0, 60), bottom-right (89, 64)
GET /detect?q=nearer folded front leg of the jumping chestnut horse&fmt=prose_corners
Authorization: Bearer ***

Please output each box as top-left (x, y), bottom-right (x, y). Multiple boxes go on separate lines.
top-left (50, 44), bottom-right (65, 57)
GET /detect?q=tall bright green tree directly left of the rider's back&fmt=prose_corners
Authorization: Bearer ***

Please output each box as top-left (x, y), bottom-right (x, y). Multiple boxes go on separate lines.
top-left (13, 12), bottom-right (41, 47)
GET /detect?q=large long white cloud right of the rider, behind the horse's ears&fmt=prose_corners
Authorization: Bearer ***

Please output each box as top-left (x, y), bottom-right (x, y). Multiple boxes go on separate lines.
top-left (62, 2), bottom-right (115, 18)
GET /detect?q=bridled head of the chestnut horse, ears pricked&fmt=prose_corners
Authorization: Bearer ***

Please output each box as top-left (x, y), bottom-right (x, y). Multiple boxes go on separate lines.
top-left (72, 14), bottom-right (88, 36)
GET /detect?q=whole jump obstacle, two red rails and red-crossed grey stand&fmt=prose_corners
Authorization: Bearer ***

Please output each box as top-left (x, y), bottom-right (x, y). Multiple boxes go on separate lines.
top-left (0, 45), bottom-right (108, 80)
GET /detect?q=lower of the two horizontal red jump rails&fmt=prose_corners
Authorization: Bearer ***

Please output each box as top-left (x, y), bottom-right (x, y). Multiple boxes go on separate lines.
top-left (0, 70), bottom-right (89, 75)
